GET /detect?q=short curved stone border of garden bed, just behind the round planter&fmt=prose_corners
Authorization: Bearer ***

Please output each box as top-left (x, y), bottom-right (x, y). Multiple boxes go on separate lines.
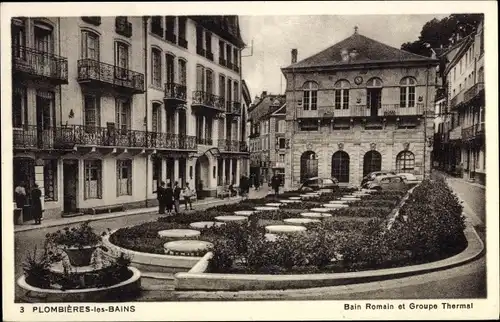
top-left (102, 230), bottom-right (201, 273)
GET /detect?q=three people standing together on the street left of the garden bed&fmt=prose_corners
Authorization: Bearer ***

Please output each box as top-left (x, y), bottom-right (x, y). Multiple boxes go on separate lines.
top-left (154, 181), bottom-right (194, 215)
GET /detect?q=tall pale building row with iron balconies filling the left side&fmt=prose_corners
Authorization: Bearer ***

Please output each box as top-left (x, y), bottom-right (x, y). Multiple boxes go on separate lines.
top-left (12, 16), bottom-right (247, 219)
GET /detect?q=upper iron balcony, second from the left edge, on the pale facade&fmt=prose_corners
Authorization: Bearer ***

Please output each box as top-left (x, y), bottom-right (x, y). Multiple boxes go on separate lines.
top-left (78, 59), bottom-right (144, 94)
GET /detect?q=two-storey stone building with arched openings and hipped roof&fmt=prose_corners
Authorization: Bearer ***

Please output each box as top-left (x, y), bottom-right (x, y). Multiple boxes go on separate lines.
top-left (282, 28), bottom-right (437, 189)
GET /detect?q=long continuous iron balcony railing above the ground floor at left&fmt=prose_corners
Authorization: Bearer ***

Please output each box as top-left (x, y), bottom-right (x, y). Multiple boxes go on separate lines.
top-left (13, 125), bottom-right (196, 150)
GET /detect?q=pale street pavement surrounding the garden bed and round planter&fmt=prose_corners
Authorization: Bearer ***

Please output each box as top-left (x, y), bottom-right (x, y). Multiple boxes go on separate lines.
top-left (15, 178), bottom-right (486, 301)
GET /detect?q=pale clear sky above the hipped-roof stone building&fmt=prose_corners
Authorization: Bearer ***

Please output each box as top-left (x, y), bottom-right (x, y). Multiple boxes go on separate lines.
top-left (239, 14), bottom-right (448, 98)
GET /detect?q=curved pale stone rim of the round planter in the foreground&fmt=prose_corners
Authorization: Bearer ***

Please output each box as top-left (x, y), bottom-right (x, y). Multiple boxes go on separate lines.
top-left (17, 267), bottom-right (141, 303)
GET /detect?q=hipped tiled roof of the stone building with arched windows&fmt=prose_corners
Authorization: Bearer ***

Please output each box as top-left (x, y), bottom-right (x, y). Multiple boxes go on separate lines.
top-left (286, 33), bottom-right (433, 69)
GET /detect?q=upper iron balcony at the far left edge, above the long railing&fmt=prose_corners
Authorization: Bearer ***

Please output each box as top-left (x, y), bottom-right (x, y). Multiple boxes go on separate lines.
top-left (12, 46), bottom-right (68, 85)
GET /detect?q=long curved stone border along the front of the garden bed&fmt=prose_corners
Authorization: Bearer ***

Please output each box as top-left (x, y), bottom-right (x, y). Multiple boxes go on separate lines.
top-left (175, 225), bottom-right (484, 291)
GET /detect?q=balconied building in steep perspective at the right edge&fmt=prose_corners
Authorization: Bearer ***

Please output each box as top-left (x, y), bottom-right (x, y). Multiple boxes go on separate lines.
top-left (443, 21), bottom-right (486, 184)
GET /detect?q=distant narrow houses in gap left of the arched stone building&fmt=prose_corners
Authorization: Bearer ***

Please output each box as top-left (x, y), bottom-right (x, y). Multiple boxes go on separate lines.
top-left (249, 92), bottom-right (286, 183)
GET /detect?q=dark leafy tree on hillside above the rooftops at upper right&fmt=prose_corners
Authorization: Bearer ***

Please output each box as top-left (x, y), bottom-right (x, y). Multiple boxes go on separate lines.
top-left (401, 14), bottom-right (484, 57)
